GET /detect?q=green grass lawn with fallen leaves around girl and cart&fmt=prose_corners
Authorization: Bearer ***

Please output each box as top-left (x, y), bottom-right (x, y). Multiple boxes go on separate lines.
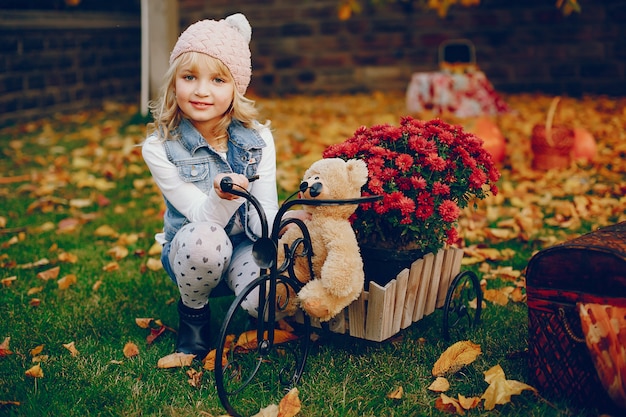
top-left (0, 101), bottom-right (616, 417)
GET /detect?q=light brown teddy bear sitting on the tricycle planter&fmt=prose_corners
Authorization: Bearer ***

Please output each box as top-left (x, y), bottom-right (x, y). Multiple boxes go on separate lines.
top-left (277, 158), bottom-right (368, 322)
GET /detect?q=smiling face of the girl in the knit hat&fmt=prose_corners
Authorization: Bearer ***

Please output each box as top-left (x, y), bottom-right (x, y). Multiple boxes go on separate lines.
top-left (174, 54), bottom-right (235, 137)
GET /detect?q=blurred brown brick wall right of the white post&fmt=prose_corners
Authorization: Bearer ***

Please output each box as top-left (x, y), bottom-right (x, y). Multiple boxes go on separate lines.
top-left (180, 0), bottom-right (626, 95)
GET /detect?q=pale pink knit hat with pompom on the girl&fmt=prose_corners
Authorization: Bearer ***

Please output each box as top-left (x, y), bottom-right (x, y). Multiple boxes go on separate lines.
top-left (170, 13), bottom-right (252, 94)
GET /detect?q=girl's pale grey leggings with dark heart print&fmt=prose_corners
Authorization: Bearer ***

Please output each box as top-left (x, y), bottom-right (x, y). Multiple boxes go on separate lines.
top-left (163, 222), bottom-right (259, 317)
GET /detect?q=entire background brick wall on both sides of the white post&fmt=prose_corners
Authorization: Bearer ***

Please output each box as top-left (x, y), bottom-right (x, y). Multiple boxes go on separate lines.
top-left (0, 0), bottom-right (626, 126)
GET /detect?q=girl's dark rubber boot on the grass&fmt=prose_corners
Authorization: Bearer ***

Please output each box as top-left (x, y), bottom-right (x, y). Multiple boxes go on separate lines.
top-left (176, 301), bottom-right (211, 360)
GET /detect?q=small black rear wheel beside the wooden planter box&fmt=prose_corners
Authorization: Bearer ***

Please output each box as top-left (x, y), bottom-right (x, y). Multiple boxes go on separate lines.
top-left (442, 271), bottom-right (483, 340)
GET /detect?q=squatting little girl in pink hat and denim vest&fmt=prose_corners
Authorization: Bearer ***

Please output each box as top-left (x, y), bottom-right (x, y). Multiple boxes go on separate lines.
top-left (142, 14), bottom-right (278, 359)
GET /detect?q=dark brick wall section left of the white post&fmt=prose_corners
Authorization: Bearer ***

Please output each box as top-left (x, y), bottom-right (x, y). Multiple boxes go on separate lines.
top-left (0, 11), bottom-right (141, 126)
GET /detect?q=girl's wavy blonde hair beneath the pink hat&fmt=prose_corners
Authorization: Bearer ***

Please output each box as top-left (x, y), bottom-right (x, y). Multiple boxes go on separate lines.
top-left (148, 52), bottom-right (259, 140)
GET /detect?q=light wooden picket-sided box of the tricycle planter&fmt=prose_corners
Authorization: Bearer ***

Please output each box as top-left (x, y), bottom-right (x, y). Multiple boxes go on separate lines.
top-left (302, 247), bottom-right (463, 342)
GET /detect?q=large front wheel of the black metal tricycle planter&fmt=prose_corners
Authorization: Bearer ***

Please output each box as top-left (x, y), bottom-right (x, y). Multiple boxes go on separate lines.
top-left (215, 275), bottom-right (310, 417)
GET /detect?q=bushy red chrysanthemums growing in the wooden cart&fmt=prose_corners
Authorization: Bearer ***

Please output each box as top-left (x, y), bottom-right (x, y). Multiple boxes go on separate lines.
top-left (323, 116), bottom-right (500, 284)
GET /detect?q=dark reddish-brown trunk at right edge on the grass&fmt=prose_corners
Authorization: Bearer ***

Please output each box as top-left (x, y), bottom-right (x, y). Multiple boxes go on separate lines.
top-left (526, 222), bottom-right (626, 412)
